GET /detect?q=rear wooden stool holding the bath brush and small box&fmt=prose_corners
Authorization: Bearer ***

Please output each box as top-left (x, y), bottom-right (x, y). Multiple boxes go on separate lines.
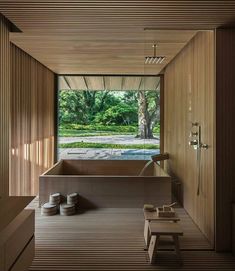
top-left (144, 210), bottom-right (180, 248)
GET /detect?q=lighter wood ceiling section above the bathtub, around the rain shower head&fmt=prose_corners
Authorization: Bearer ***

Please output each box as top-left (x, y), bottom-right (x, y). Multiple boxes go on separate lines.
top-left (8, 28), bottom-right (196, 75)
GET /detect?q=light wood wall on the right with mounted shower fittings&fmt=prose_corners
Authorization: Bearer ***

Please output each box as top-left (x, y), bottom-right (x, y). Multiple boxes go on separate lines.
top-left (164, 31), bottom-right (215, 244)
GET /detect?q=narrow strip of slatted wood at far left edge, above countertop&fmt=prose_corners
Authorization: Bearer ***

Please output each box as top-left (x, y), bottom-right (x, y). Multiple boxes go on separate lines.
top-left (0, 14), bottom-right (10, 197)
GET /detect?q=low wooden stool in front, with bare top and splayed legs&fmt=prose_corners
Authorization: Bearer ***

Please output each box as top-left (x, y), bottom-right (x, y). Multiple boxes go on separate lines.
top-left (148, 221), bottom-right (183, 263)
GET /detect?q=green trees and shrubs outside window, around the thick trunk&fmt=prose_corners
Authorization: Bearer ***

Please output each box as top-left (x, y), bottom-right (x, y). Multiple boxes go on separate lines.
top-left (59, 90), bottom-right (160, 136)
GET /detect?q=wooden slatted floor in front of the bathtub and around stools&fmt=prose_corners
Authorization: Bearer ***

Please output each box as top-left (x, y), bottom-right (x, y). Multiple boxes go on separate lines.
top-left (29, 208), bottom-right (235, 271)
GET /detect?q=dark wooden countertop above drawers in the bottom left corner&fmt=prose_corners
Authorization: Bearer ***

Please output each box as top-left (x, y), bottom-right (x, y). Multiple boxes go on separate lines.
top-left (0, 196), bottom-right (35, 231)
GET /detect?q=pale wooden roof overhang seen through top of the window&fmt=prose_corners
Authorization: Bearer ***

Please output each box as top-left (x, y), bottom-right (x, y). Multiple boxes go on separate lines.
top-left (59, 76), bottom-right (160, 91)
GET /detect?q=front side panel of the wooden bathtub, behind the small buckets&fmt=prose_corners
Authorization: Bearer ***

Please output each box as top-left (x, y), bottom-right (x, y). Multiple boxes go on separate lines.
top-left (39, 178), bottom-right (172, 209)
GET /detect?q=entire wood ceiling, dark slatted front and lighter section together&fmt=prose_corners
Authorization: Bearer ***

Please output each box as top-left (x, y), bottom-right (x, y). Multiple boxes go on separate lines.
top-left (0, 0), bottom-right (235, 74)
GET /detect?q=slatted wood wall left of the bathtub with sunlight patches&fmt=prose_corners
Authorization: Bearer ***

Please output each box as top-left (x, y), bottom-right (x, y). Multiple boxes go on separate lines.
top-left (10, 44), bottom-right (55, 198)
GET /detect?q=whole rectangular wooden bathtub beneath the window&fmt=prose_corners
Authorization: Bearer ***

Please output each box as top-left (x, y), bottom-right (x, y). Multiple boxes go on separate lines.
top-left (39, 160), bottom-right (171, 209)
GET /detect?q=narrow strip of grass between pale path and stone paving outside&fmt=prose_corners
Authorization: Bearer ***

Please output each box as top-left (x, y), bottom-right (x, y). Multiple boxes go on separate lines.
top-left (59, 142), bottom-right (159, 149)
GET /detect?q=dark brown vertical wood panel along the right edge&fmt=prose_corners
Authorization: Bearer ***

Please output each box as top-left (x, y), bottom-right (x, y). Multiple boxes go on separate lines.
top-left (216, 29), bottom-right (235, 251)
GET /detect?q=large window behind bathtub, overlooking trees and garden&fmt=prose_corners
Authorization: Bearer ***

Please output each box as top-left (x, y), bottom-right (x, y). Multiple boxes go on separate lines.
top-left (58, 76), bottom-right (160, 160)
